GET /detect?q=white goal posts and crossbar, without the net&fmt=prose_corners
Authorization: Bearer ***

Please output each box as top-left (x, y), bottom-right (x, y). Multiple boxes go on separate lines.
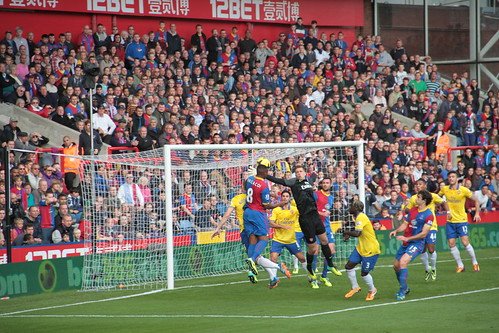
top-left (163, 141), bottom-right (365, 290)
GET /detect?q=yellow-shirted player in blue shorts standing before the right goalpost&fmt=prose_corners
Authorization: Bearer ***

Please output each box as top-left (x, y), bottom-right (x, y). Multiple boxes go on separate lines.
top-left (343, 201), bottom-right (381, 301)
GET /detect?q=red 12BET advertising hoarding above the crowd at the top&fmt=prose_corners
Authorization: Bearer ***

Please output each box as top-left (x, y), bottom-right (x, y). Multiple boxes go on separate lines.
top-left (0, 0), bottom-right (364, 27)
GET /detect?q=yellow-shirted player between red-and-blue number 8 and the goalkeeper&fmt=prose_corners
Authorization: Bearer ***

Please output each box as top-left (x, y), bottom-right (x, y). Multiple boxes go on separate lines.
top-left (270, 190), bottom-right (307, 276)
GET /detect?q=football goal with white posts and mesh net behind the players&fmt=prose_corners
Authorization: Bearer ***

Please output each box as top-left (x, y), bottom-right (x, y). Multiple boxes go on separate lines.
top-left (81, 142), bottom-right (364, 290)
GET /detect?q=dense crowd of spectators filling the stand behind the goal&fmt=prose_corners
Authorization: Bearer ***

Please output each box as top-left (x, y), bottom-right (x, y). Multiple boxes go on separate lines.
top-left (0, 18), bottom-right (499, 245)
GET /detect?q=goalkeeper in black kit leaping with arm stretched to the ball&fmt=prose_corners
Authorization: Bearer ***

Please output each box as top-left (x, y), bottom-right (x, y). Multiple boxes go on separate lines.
top-left (266, 166), bottom-right (340, 283)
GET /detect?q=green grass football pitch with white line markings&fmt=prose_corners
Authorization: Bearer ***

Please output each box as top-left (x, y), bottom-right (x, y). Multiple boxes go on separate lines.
top-left (0, 249), bottom-right (499, 333)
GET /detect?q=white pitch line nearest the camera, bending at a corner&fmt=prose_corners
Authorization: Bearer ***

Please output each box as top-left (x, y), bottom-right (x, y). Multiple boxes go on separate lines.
top-left (1, 287), bottom-right (499, 319)
